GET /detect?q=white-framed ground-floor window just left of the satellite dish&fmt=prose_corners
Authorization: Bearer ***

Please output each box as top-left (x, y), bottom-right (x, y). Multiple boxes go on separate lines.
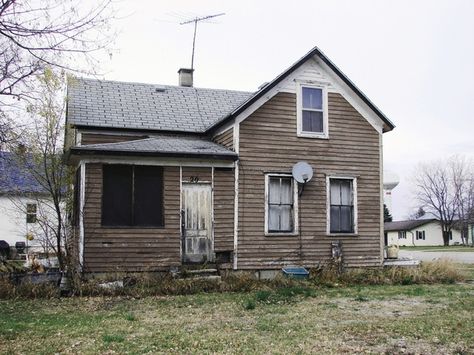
top-left (267, 176), bottom-right (294, 233)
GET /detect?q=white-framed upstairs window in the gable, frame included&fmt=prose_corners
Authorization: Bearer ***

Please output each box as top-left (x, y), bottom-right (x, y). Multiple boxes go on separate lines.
top-left (297, 85), bottom-right (328, 138)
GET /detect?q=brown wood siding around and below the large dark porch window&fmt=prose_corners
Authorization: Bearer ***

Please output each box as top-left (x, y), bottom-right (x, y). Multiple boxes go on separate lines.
top-left (84, 164), bottom-right (181, 272)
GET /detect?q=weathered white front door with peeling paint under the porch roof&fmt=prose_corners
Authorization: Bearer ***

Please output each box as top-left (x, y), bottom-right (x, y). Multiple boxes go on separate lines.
top-left (181, 183), bottom-right (213, 263)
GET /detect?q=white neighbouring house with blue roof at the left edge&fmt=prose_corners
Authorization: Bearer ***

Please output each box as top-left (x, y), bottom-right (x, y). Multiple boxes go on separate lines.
top-left (0, 152), bottom-right (52, 253)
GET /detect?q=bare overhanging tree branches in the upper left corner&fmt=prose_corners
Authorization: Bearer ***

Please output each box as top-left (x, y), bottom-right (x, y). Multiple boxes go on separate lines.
top-left (0, 0), bottom-right (114, 144)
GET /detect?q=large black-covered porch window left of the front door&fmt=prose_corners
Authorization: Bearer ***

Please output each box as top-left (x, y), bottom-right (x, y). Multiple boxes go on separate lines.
top-left (102, 165), bottom-right (164, 227)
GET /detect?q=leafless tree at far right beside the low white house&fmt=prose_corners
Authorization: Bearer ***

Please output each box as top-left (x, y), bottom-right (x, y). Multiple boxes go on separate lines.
top-left (414, 156), bottom-right (474, 245)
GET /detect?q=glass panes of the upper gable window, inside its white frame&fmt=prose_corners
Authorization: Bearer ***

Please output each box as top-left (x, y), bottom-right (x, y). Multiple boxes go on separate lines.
top-left (301, 87), bottom-right (324, 133)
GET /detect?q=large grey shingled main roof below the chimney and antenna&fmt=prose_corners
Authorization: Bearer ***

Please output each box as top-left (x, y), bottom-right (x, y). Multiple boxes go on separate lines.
top-left (67, 78), bottom-right (252, 133)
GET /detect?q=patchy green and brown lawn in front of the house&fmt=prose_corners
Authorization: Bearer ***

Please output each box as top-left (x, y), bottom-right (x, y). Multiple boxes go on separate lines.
top-left (0, 284), bottom-right (474, 354)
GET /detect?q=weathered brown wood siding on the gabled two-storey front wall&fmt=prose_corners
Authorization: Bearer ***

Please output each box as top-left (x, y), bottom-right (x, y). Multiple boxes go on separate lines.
top-left (238, 93), bottom-right (381, 269)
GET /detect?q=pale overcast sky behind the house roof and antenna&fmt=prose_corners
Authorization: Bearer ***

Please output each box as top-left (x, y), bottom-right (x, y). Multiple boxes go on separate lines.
top-left (93, 0), bottom-right (474, 219)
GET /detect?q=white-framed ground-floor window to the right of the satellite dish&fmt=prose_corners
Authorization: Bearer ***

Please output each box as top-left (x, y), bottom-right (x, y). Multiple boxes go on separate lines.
top-left (330, 179), bottom-right (354, 233)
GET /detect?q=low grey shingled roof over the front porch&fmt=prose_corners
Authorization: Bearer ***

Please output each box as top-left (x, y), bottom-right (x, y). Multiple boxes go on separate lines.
top-left (72, 135), bottom-right (237, 159)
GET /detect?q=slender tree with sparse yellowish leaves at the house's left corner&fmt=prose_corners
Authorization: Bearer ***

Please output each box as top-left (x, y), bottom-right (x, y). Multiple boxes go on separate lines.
top-left (11, 68), bottom-right (72, 270)
